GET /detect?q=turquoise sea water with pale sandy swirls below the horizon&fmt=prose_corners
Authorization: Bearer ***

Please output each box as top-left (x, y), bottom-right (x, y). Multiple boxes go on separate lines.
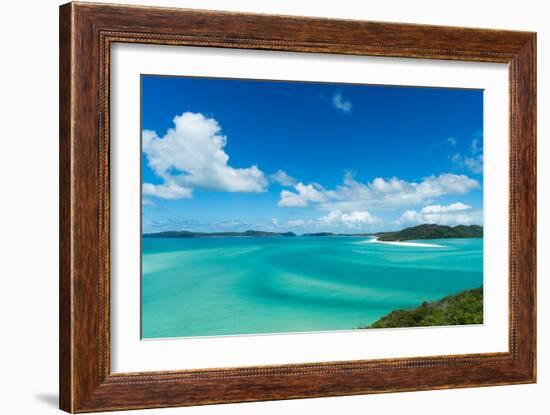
top-left (142, 237), bottom-right (483, 338)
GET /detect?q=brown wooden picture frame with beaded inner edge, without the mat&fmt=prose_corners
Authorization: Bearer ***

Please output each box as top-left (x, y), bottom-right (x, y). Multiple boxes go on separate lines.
top-left (59, 3), bottom-right (536, 412)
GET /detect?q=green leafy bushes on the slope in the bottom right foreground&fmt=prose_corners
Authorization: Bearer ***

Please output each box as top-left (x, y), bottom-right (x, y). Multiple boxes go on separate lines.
top-left (359, 287), bottom-right (483, 329)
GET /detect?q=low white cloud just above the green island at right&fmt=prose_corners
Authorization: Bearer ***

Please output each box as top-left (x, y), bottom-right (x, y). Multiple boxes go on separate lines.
top-left (395, 202), bottom-right (483, 225)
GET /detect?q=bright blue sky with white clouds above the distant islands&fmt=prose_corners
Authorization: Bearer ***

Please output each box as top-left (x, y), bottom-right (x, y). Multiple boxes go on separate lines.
top-left (141, 76), bottom-right (483, 233)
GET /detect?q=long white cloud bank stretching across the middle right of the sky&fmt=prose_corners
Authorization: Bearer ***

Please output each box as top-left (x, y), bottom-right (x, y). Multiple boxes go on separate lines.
top-left (279, 173), bottom-right (479, 212)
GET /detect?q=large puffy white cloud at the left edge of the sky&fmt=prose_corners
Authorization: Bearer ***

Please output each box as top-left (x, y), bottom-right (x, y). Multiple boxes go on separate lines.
top-left (142, 112), bottom-right (268, 199)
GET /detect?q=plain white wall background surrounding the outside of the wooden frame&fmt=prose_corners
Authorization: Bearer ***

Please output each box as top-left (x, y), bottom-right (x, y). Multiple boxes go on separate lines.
top-left (0, 0), bottom-right (550, 415)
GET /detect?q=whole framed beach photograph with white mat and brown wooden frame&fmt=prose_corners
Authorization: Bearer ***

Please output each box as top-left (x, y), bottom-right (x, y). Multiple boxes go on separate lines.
top-left (60, 3), bottom-right (536, 412)
